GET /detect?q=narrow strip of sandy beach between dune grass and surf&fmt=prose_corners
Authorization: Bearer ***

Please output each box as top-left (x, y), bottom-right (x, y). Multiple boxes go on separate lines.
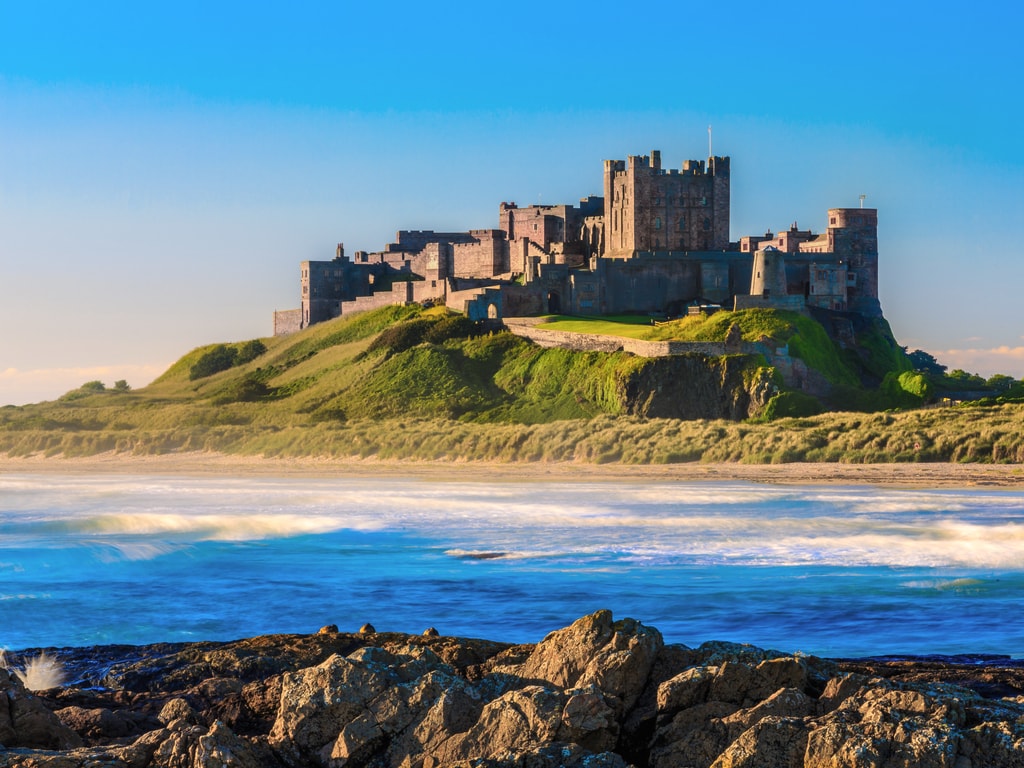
top-left (0, 453), bottom-right (1024, 487)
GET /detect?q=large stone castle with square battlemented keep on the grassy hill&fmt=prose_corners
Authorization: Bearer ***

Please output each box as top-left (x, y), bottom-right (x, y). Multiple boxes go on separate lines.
top-left (273, 151), bottom-right (882, 335)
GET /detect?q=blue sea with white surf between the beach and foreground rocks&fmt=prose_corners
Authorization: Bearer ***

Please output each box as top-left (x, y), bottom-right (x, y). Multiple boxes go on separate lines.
top-left (0, 473), bottom-right (1024, 657)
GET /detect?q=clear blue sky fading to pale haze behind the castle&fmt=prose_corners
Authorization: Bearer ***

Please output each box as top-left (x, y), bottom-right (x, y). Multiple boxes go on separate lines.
top-left (0, 0), bottom-right (1024, 404)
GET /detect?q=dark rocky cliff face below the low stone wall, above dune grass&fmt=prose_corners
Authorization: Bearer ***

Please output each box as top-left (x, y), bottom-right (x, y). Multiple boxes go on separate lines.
top-left (617, 354), bottom-right (774, 421)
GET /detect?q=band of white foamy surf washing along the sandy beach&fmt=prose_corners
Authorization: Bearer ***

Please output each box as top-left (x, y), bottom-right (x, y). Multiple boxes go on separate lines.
top-left (0, 476), bottom-right (1024, 569)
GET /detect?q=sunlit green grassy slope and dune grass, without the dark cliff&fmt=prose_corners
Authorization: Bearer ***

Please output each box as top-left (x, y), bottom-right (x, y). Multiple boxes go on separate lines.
top-left (0, 307), bottom-right (1024, 463)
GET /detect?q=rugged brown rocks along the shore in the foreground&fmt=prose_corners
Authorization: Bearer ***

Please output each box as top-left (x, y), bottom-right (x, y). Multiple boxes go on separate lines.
top-left (0, 611), bottom-right (1024, 768)
